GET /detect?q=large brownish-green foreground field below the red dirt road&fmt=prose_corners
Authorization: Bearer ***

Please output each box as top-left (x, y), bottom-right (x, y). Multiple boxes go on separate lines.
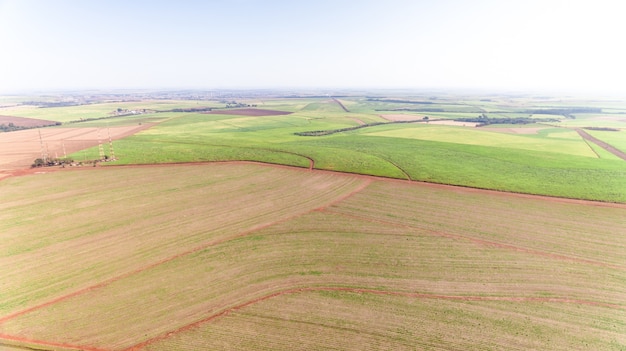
top-left (0, 165), bottom-right (626, 350)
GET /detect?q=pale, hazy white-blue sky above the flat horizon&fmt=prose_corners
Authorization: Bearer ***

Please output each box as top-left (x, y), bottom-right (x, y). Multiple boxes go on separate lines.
top-left (0, 0), bottom-right (626, 97)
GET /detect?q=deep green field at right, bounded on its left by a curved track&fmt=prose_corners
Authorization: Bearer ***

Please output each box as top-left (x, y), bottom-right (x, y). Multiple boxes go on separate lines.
top-left (286, 135), bottom-right (626, 202)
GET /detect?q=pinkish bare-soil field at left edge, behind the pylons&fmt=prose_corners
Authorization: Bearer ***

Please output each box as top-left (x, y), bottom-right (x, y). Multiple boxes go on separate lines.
top-left (0, 123), bottom-right (153, 179)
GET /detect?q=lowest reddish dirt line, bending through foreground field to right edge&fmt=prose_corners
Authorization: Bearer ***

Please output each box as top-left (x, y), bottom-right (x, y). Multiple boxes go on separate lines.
top-left (123, 286), bottom-right (626, 351)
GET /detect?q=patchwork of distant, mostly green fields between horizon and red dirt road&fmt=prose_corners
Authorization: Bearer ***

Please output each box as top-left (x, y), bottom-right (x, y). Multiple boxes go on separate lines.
top-left (0, 94), bottom-right (626, 203)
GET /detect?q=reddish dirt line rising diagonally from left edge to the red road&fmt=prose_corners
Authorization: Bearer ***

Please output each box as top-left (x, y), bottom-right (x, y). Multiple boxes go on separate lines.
top-left (0, 180), bottom-right (372, 325)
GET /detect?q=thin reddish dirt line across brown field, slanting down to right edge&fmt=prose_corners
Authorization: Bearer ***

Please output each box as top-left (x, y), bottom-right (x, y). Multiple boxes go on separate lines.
top-left (324, 209), bottom-right (626, 271)
